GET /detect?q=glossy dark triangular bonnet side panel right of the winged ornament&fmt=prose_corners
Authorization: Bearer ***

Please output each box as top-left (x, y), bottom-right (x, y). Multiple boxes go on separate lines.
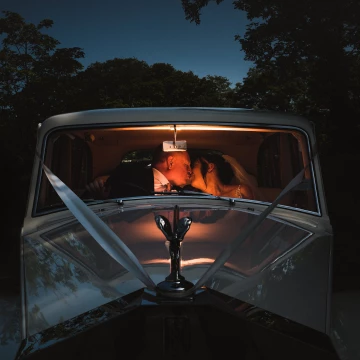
top-left (222, 236), bottom-right (330, 332)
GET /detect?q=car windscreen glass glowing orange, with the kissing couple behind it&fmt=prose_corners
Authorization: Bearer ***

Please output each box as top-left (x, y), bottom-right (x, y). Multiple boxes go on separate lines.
top-left (35, 124), bottom-right (319, 214)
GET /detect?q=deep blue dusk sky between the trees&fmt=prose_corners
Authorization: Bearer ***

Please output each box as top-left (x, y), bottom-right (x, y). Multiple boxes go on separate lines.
top-left (0, 0), bottom-right (252, 85)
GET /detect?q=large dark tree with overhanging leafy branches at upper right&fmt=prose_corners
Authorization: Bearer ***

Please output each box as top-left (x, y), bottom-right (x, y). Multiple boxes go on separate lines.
top-left (182, 0), bottom-right (360, 137)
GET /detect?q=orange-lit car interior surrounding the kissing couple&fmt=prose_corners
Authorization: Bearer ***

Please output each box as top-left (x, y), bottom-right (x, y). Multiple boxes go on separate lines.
top-left (36, 124), bottom-right (318, 213)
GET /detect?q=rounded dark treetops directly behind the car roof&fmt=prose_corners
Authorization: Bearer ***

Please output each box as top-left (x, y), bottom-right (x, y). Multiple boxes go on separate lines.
top-left (76, 58), bottom-right (231, 110)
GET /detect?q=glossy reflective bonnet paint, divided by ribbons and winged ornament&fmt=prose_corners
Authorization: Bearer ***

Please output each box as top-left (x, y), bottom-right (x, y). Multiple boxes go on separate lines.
top-left (24, 205), bottom-right (330, 335)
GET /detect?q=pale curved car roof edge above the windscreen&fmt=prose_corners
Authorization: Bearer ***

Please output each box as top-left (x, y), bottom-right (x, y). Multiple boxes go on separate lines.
top-left (40, 107), bottom-right (313, 133)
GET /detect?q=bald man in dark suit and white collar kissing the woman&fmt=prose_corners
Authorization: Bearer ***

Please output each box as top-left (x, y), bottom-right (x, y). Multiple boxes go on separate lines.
top-left (86, 144), bottom-right (192, 199)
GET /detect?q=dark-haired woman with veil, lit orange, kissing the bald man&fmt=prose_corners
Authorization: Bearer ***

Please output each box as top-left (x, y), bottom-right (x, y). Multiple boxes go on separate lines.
top-left (191, 153), bottom-right (257, 199)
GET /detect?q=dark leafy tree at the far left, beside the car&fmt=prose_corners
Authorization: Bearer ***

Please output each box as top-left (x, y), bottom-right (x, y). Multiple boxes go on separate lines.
top-left (0, 11), bottom-right (84, 163)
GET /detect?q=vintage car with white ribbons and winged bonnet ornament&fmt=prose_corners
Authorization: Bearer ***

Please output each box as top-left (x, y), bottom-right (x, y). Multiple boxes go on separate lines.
top-left (0, 108), bottom-right (348, 360)
